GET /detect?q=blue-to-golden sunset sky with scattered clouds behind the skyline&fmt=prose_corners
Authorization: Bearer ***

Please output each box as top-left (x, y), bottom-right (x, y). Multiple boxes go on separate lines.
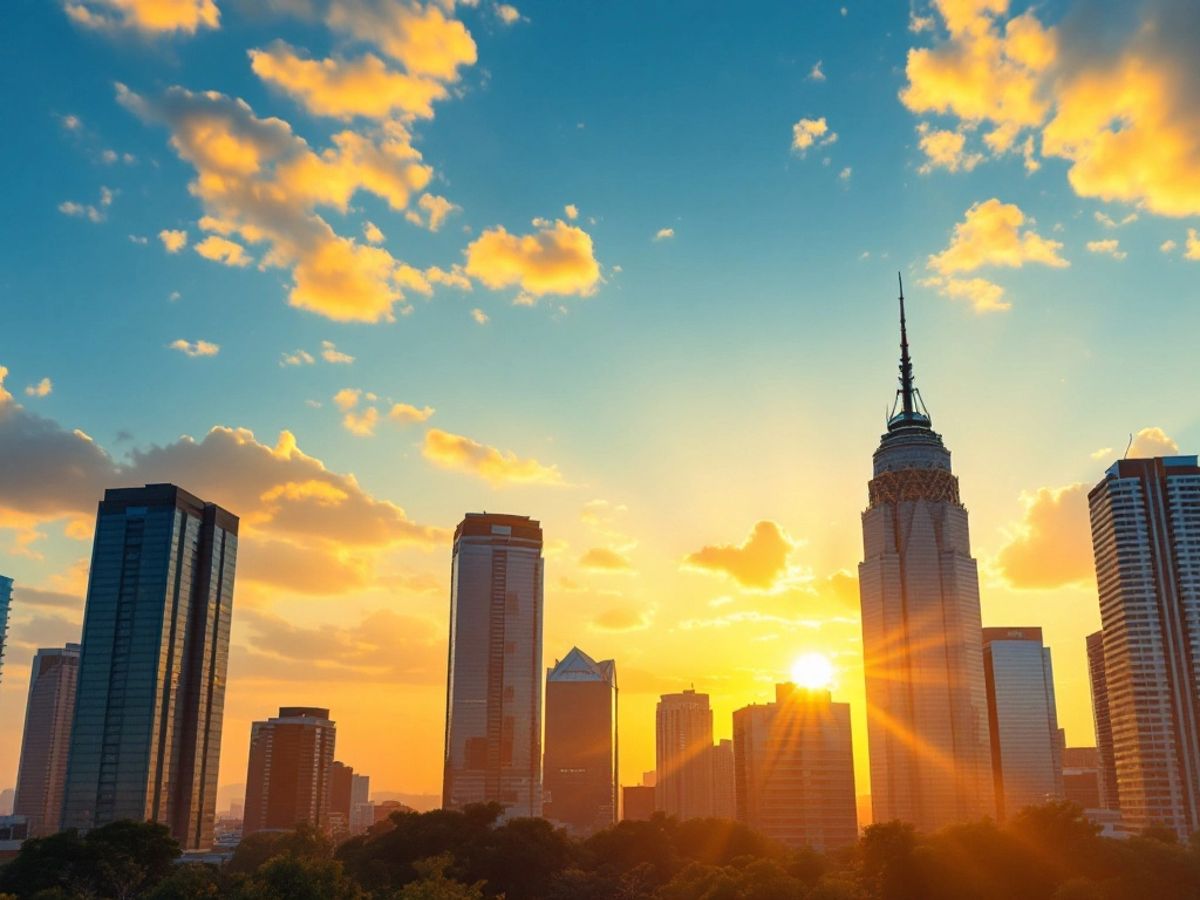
top-left (0, 0), bottom-right (1200, 804)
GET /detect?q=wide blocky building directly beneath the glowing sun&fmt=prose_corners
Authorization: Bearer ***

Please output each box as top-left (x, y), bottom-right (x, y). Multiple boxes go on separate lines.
top-left (733, 684), bottom-right (858, 851)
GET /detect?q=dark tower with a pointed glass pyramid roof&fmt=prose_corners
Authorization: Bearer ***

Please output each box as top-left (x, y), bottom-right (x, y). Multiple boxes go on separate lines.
top-left (544, 647), bottom-right (618, 836)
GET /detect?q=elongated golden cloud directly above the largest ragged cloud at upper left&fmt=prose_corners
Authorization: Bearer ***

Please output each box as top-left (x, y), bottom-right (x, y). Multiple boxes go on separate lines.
top-left (250, 41), bottom-right (448, 120)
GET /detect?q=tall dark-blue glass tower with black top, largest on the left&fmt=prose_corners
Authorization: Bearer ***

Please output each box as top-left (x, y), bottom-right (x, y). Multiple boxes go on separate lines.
top-left (62, 485), bottom-right (238, 850)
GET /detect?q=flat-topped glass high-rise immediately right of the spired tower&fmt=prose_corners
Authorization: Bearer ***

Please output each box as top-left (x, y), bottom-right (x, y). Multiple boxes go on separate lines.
top-left (983, 628), bottom-right (1062, 821)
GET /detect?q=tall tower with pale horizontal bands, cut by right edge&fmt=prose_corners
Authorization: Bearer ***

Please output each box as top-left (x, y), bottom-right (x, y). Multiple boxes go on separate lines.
top-left (1087, 456), bottom-right (1200, 838)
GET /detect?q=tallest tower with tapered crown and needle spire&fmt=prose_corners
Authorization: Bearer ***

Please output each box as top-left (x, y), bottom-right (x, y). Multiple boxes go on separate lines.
top-left (858, 284), bottom-right (995, 830)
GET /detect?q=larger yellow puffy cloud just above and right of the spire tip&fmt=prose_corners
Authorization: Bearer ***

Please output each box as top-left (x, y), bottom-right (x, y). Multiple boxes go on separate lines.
top-left (928, 197), bottom-right (1069, 275)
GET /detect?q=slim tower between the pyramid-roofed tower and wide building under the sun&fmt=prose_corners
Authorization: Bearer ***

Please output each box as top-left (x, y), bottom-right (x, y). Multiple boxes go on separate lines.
top-left (654, 690), bottom-right (713, 818)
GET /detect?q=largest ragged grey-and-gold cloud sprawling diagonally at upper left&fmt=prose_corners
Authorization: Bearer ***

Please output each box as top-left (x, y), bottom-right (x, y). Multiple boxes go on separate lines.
top-left (118, 84), bottom-right (442, 322)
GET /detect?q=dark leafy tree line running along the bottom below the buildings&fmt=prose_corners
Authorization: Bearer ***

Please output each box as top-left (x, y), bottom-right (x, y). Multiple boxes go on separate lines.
top-left (0, 803), bottom-right (1200, 900)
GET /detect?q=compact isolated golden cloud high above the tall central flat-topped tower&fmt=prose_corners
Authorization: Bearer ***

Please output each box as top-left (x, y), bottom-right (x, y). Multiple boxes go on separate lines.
top-left (464, 220), bottom-right (600, 298)
